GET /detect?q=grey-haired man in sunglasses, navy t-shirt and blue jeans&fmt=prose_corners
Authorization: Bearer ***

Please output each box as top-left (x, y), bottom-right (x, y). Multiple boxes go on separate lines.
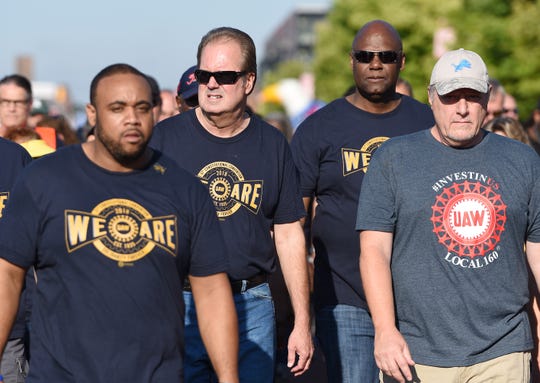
top-left (151, 27), bottom-right (313, 383)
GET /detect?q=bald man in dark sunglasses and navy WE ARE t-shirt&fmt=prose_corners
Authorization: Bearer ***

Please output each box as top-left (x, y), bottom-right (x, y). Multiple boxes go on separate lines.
top-left (292, 20), bottom-right (433, 383)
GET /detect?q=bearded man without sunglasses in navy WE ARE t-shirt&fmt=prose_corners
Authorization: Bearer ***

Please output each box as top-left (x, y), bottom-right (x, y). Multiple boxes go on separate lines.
top-left (0, 64), bottom-right (238, 383)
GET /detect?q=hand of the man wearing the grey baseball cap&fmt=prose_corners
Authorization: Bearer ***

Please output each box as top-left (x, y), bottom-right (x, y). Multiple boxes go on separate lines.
top-left (375, 328), bottom-right (414, 383)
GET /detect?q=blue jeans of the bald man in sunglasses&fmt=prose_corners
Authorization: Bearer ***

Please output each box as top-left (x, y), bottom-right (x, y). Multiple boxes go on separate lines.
top-left (315, 305), bottom-right (379, 383)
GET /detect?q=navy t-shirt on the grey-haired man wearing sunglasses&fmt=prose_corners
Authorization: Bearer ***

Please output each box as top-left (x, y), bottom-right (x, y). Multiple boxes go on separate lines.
top-left (150, 110), bottom-right (305, 279)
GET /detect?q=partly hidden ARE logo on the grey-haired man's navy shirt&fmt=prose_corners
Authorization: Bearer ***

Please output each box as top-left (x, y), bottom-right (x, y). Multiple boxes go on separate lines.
top-left (197, 161), bottom-right (263, 219)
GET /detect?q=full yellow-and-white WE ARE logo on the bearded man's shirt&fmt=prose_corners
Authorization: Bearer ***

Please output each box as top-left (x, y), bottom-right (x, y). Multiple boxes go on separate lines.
top-left (64, 198), bottom-right (178, 267)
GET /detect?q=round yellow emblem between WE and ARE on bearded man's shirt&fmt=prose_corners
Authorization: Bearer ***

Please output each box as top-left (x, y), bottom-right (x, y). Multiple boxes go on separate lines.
top-left (92, 199), bottom-right (155, 263)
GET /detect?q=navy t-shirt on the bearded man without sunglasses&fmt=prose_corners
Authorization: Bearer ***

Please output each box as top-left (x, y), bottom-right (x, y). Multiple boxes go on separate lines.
top-left (0, 145), bottom-right (227, 383)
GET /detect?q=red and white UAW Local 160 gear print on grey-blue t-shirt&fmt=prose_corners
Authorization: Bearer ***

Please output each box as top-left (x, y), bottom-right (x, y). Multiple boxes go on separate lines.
top-left (431, 177), bottom-right (506, 268)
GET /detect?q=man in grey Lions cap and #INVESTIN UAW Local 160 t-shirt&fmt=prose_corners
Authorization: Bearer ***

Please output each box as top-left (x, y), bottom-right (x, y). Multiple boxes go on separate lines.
top-left (356, 49), bottom-right (540, 383)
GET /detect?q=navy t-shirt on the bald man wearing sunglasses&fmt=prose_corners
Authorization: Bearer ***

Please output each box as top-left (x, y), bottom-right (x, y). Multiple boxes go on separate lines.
top-left (291, 96), bottom-right (434, 309)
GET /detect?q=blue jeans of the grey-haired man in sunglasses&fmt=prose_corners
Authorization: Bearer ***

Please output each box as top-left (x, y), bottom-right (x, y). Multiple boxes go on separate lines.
top-left (184, 283), bottom-right (276, 383)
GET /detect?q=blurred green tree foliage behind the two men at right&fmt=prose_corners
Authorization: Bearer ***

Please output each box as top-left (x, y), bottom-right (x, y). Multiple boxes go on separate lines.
top-left (314, 0), bottom-right (540, 116)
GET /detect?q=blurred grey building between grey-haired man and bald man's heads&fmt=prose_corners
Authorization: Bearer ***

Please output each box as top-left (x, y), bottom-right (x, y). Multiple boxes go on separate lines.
top-left (260, 5), bottom-right (328, 73)
